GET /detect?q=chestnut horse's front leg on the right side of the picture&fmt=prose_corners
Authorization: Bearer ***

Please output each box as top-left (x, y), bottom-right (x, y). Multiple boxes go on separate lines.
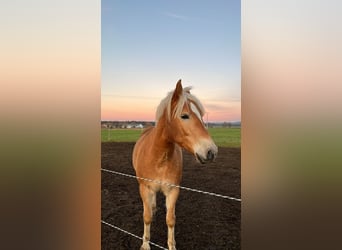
top-left (166, 188), bottom-right (179, 250)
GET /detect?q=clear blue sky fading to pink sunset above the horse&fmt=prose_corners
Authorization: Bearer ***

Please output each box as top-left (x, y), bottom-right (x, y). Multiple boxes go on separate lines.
top-left (101, 0), bottom-right (241, 122)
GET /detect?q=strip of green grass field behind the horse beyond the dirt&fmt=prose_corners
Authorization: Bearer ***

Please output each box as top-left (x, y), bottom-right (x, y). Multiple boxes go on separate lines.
top-left (101, 128), bottom-right (241, 147)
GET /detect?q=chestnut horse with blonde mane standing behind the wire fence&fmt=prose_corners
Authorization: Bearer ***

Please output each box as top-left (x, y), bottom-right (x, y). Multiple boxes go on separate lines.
top-left (132, 80), bottom-right (218, 250)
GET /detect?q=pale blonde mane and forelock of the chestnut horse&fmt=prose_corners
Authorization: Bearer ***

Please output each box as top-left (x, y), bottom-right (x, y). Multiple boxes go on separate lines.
top-left (156, 87), bottom-right (205, 122)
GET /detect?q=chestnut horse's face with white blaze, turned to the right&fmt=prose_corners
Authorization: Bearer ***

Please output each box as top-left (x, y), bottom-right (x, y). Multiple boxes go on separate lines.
top-left (171, 100), bottom-right (218, 164)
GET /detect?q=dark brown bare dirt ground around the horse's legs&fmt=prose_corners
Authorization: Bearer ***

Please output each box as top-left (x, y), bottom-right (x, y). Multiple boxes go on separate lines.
top-left (101, 142), bottom-right (241, 250)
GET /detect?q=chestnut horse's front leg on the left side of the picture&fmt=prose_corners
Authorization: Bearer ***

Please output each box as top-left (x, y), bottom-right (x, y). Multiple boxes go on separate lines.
top-left (139, 184), bottom-right (156, 250)
